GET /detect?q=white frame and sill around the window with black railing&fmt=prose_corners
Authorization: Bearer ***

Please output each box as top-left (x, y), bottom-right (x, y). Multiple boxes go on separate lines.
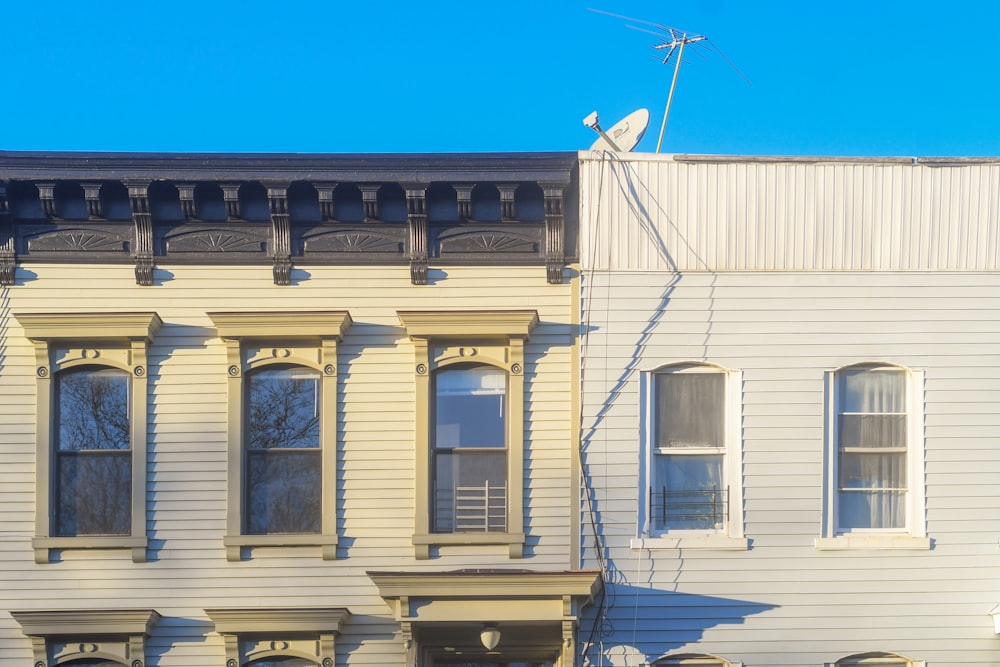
top-left (631, 361), bottom-right (749, 551)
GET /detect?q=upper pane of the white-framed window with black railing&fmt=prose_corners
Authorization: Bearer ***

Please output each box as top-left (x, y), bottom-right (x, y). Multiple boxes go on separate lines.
top-left (656, 373), bottom-right (725, 447)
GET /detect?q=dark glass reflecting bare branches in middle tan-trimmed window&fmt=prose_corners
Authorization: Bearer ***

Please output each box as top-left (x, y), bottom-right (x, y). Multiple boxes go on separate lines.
top-left (245, 366), bottom-right (322, 535)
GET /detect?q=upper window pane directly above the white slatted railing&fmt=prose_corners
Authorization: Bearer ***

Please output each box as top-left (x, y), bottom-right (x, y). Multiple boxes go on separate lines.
top-left (434, 368), bottom-right (507, 448)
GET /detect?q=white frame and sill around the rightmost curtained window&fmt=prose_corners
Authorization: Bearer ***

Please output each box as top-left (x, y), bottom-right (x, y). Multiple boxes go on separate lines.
top-left (816, 361), bottom-right (930, 550)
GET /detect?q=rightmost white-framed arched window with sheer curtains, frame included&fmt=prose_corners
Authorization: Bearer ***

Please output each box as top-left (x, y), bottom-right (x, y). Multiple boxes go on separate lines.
top-left (818, 364), bottom-right (925, 547)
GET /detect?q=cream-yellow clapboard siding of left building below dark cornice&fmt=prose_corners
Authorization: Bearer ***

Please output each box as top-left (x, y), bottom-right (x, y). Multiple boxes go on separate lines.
top-left (0, 265), bottom-right (578, 667)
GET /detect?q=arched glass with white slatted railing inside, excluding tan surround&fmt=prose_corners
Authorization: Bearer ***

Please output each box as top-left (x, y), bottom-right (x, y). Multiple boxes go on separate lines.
top-left (432, 364), bottom-right (507, 533)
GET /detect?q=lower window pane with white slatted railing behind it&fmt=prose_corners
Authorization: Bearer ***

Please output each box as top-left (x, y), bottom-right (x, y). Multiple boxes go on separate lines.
top-left (433, 451), bottom-right (507, 533)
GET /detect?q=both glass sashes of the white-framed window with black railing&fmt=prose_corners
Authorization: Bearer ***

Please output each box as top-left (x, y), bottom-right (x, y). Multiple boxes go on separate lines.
top-left (650, 369), bottom-right (728, 532)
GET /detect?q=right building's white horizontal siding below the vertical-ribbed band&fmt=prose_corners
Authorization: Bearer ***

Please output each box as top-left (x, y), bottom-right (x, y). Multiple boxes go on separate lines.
top-left (582, 270), bottom-right (1000, 667)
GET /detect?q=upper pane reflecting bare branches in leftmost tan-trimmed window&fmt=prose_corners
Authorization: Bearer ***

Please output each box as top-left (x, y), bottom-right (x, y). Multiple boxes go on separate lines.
top-left (55, 368), bottom-right (131, 451)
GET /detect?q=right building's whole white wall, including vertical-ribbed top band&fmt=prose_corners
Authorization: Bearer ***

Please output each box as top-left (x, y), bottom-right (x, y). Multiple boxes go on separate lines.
top-left (581, 156), bottom-right (1000, 667)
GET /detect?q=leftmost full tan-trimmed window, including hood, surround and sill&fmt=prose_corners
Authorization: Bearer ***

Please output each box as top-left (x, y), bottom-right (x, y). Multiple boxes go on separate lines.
top-left (14, 313), bottom-right (162, 563)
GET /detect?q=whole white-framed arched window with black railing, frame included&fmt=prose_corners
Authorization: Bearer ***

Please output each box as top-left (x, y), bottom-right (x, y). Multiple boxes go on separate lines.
top-left (640, 364), bottom-right (745, 549)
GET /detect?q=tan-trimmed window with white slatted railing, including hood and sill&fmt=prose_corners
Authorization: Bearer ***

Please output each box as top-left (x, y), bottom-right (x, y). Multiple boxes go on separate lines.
top-left (397, 310), bottom-right (538, 559)
